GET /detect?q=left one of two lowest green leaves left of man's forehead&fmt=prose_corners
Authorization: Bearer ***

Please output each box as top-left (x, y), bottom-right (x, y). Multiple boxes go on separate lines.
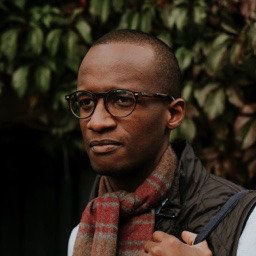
top-left (12, 66), bottom-right (29, 98)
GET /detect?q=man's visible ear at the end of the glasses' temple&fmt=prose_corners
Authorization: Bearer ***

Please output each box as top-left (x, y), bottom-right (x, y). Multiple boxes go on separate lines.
top-left (167, 98), bottom-right (186, 130)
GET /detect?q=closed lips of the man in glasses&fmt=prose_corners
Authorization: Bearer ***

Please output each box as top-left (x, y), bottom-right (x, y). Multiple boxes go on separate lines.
top-left (89, 139), bottom-right (121, 154)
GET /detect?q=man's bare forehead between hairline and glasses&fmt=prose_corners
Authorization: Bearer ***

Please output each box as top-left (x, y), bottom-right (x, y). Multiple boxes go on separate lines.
top-left (78, 43), bottom-right (155, 92)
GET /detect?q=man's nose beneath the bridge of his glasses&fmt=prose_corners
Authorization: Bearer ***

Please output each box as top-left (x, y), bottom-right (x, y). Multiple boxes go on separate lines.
top-left (87, 99), bottom-right (116, 132)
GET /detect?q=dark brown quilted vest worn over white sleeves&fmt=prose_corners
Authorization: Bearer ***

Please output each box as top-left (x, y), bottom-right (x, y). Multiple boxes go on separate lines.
top-left (155, 142), bottom-right (256, 256)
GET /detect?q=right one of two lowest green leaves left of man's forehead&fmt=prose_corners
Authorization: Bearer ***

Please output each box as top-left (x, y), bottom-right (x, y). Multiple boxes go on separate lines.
top-left (35, 66), bottom-right (51, 93)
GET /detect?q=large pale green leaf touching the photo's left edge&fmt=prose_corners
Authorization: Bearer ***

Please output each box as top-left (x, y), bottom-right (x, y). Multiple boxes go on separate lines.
top-left (0, 28), bottom-right (20, 61)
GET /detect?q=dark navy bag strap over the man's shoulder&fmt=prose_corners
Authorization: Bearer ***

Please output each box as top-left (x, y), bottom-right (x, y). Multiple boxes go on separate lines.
top-left (194, 190), bottom-right (249, 244)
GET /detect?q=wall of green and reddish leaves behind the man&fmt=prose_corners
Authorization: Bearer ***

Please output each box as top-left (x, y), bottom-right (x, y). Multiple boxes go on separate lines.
top-left (0, 0), bottom-right (256, 186)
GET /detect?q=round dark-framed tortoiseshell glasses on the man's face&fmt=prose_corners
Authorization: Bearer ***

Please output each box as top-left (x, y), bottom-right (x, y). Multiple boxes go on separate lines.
top-left (65, 90), bottom-right (174, 119)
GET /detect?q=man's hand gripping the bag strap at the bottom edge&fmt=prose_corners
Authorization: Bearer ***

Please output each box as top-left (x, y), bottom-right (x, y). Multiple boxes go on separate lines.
top-left (140, 231), bottom-right (212, 256)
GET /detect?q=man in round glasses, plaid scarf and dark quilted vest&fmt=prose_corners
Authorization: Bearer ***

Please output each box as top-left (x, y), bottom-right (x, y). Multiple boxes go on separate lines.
top-left (66, 30), bottom-right (256, 256)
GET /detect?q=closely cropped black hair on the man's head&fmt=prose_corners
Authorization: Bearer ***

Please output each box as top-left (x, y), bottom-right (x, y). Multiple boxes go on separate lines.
top-left (92, 29), bottom-right (181, 98)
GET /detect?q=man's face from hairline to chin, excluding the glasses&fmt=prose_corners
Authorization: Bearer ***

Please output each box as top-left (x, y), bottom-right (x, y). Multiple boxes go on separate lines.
top-left (77, 43), bottom-right (169, 176)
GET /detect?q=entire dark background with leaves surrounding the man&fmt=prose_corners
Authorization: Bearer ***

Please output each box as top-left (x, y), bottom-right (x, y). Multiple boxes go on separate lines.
top-left (0, 0), bottom-right (256, 256)
